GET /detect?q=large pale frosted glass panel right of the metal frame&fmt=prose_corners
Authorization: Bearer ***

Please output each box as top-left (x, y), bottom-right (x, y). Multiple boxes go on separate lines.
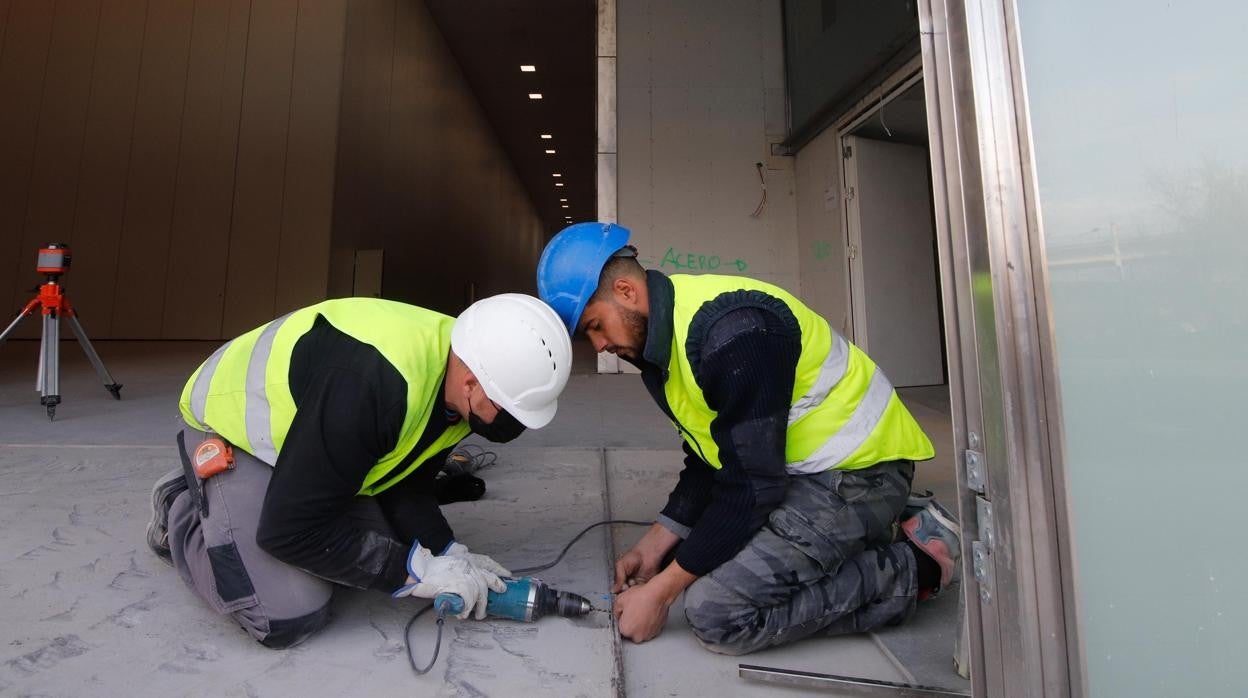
top-left (1018, 0), bottom-right (1248, 697)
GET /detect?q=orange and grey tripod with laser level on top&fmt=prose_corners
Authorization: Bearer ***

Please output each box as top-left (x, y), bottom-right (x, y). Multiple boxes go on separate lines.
top-left (0, 242), bottom-right (121, 420)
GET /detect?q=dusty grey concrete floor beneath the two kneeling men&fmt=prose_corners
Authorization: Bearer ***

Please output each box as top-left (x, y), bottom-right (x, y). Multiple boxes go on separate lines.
top-left (0, 342), bottom-right (967, 697)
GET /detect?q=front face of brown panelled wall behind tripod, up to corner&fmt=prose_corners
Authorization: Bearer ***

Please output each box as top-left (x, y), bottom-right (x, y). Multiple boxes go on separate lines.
top-left (0, 0), bottom-right (346, 338)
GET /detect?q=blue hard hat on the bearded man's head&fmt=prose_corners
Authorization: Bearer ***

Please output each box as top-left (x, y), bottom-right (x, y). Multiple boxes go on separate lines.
top-left (538, 222), bottom-right (629, 335)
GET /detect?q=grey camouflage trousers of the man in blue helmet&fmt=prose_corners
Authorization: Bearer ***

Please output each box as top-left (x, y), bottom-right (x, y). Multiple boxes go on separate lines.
top-left (685, 461), bottom-right (919, 654)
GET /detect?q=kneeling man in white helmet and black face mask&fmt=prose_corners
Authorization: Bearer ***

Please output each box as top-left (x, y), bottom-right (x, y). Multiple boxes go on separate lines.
top-left (147, 293), bottom-right (572, 648)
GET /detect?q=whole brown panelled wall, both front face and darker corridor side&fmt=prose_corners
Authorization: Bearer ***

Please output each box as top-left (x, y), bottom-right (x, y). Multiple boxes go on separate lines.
top-left (0, 0), bottom-right (544, 338)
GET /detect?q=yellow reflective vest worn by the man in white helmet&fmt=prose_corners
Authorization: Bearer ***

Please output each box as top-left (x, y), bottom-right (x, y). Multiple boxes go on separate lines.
top-left (180, 298), bottom-right (469, 494)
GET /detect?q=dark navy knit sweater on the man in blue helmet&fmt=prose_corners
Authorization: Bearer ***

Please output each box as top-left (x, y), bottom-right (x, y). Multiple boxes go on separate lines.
top-left (635, 271), bottom-right (801, 576)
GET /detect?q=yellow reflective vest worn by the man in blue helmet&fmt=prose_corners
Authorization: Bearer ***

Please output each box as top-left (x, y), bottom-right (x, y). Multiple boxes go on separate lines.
top-left (664, 275), bottom-right (935, 473)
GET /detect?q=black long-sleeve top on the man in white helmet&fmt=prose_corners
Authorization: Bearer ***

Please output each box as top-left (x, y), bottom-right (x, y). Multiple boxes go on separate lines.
top-left (256, 317), bottom-right (459, 592)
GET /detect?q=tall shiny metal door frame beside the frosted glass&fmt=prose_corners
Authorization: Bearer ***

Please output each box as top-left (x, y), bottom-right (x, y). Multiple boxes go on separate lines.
top-left (919, 0), bottom-right (1087, 697)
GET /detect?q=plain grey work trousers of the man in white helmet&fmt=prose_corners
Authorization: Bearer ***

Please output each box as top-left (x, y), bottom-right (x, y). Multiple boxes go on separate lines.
top-left (168, 427), bottom-right (394, 649)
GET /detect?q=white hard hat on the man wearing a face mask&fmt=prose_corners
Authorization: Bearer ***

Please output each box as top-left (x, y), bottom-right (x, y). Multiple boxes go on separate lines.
top-left (451, 293), bottom-right (572, 428)
